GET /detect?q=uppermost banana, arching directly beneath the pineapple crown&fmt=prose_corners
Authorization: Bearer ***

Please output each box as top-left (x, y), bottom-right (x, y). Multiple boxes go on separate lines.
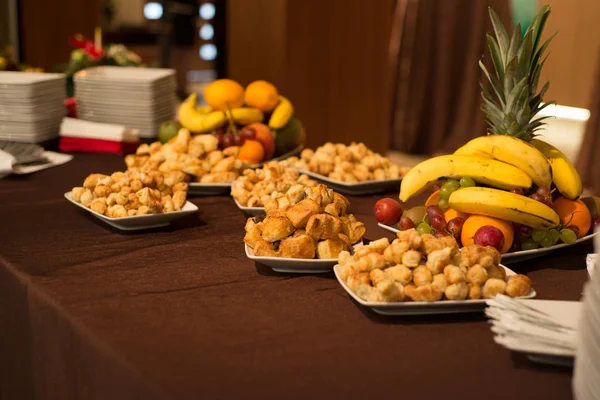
top-left (454, 135), bottom-right (552, 188)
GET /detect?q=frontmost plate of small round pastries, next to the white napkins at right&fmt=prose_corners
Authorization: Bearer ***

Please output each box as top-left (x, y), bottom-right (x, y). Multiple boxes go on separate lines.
top-left (334, 229), bottom-right (536, 315)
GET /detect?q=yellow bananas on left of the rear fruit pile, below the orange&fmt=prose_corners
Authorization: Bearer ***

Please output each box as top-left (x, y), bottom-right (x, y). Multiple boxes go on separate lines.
top-left (177, 93), bottom-right (264, 133)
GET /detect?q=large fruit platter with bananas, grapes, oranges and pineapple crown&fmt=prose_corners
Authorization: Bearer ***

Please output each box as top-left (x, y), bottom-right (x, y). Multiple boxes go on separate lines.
top-left (375, 7), bottom-right (600, 263)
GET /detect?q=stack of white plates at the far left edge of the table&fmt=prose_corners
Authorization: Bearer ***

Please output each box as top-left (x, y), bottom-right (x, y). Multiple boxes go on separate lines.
top-left (0, 71), bottom-right (66, 143)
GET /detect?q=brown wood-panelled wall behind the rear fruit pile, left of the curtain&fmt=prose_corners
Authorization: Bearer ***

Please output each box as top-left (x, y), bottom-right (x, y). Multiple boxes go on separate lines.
top-left (227, 0), bottom-right (395, 151)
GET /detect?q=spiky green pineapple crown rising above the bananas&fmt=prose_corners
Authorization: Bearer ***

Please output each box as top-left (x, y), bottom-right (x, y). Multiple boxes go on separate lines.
top-left (479, 6), bottom-right (555, 142)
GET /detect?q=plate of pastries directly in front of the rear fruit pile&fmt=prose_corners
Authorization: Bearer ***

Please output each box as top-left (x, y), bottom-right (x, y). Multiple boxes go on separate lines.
top-left (125, 128), bottom-right (249, 196)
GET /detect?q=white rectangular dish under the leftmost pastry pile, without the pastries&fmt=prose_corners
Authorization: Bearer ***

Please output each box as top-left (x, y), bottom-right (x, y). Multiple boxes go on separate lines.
top-left (65, 192), bottom-right (198, 231)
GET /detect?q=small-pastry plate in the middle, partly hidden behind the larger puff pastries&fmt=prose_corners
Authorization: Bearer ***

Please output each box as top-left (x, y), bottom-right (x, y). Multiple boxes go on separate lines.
top-left (231, 161), bottom-right (318, 215)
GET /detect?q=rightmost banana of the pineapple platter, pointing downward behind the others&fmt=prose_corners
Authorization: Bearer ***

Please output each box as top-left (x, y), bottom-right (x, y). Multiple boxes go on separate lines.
top-left (531, 139), bottom-right (583, 200)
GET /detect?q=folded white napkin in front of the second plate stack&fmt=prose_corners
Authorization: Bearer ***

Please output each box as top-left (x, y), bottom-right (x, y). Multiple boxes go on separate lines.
top-left (60, 118), bottom-right (139, 143)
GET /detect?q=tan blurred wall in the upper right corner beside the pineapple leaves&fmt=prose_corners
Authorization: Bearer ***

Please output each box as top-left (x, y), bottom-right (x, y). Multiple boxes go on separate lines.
top-left (539, 0), bottom-right (600, 108)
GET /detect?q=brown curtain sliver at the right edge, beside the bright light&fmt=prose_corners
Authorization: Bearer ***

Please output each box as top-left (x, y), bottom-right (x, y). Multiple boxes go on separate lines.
top-left (575, 52), bottom-right (600, 194)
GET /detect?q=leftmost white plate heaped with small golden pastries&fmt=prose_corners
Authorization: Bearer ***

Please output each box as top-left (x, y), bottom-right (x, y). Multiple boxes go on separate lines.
top-left (64, 171), bottom-right (198, 231)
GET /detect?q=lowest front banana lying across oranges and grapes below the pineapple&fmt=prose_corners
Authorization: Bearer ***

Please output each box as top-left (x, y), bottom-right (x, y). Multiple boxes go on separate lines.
top-left (448, 187), bottom-right (560, 229)
